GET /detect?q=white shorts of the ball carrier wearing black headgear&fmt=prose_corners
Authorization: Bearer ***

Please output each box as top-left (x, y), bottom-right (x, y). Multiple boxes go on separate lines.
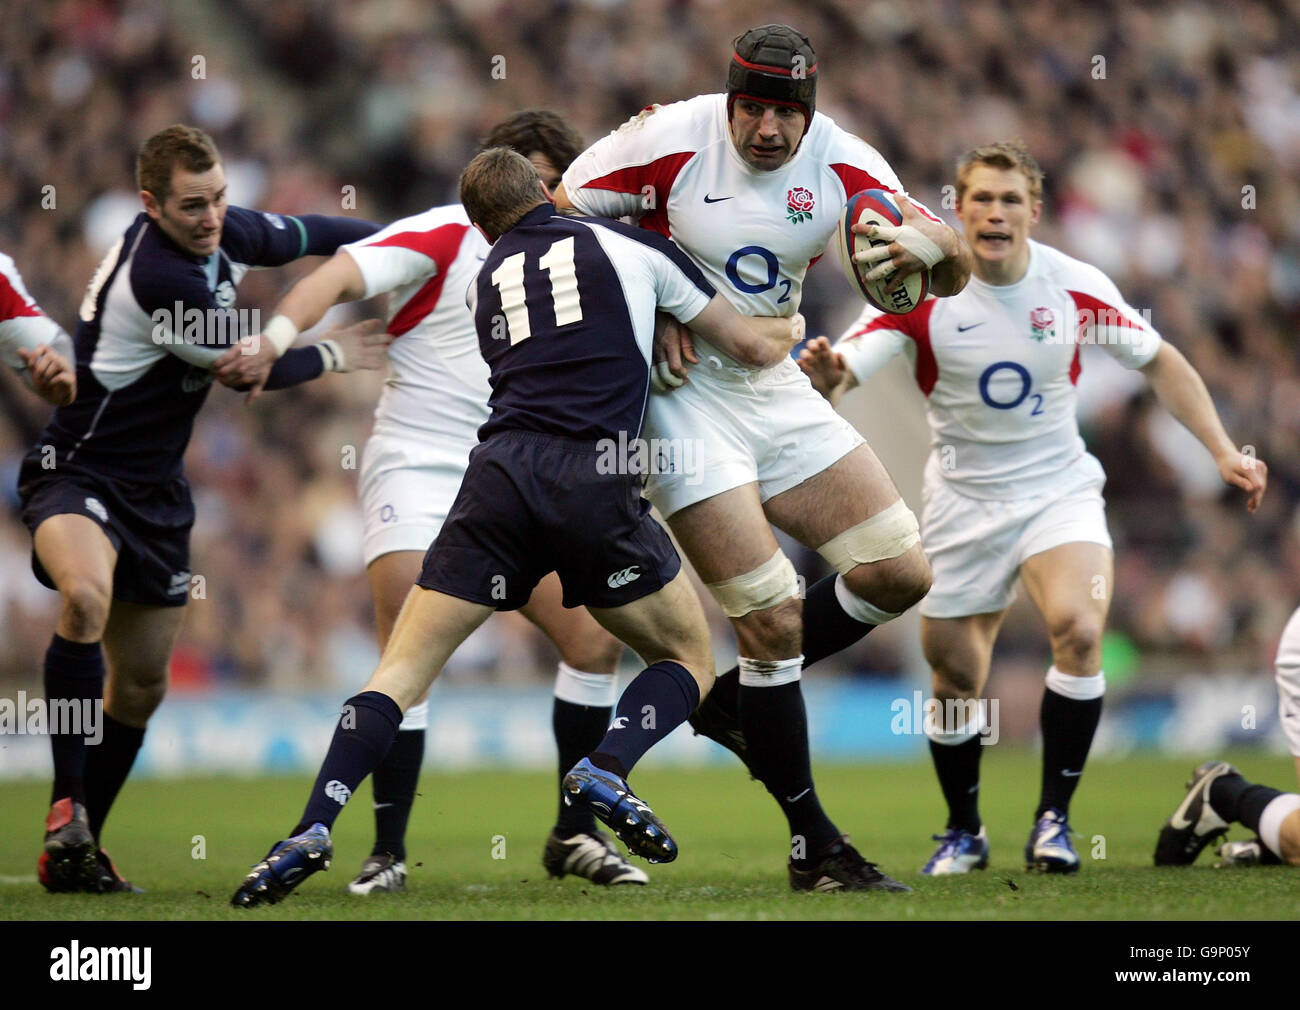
top-left (645, 347), bottom-right (863, 519)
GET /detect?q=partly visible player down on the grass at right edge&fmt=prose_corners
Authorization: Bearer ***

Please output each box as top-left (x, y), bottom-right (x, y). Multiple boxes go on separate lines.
top-left (1156, 608), bottom-right (1300, 866)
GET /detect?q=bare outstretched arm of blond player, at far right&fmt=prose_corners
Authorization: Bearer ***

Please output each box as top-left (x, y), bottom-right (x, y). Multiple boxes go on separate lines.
top-left (1141, 343), bottom-right (1269, 512)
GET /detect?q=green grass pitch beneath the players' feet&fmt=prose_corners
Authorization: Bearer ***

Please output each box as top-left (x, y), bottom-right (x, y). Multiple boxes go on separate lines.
top-left (0, 749), bottom-right (1300, 920)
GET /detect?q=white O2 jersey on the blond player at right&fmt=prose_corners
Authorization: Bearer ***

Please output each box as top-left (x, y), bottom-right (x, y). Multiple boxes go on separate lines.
top-left (836, 240), bottom-right (1161, 499)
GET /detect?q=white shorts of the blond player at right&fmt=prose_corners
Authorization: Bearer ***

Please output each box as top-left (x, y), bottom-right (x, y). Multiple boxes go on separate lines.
top-left (920, 452), bottom-right (1113, 617)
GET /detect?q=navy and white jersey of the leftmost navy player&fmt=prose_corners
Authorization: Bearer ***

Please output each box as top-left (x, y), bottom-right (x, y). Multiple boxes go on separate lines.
top-left (40, 207), bottom-right (376, 484)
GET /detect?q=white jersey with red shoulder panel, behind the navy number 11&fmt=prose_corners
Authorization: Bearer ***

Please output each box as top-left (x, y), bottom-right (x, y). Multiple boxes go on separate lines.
top-left (342, 204), bottom-right (491, 444)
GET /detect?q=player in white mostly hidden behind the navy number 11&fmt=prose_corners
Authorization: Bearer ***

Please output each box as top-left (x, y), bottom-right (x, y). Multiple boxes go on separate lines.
top-left (218, 109), bottom-right (649, 894)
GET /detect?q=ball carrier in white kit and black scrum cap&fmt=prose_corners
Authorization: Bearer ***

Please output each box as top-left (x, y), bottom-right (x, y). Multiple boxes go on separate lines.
top-left (556, 25), bottom-right (970, 890)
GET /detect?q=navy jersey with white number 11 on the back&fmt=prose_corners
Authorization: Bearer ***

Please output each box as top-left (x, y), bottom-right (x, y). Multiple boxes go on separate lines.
top-left (468, 204), bottom-right (716, 441)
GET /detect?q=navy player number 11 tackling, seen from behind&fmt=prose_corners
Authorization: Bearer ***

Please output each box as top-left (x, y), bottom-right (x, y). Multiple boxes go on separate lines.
top-left (231, 147), bottom-right (802, 907)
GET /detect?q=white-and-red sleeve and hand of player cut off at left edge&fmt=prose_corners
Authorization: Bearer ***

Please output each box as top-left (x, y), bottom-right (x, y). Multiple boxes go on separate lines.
top-left (0, 252), bottom-right (77, 407)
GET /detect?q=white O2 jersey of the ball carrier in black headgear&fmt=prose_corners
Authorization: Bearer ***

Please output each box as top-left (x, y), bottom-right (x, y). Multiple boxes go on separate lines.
top-left (564, 95), bottom-right (937, 369)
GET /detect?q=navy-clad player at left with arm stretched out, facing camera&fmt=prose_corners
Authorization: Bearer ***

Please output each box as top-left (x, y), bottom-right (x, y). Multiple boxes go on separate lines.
top-left (26, 125), bottom-right (386, 892)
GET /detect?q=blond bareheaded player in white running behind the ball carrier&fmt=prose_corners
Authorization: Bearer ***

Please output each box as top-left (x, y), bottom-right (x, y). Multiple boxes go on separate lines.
top-left (800, 143), bottom-right (1268, 875)
